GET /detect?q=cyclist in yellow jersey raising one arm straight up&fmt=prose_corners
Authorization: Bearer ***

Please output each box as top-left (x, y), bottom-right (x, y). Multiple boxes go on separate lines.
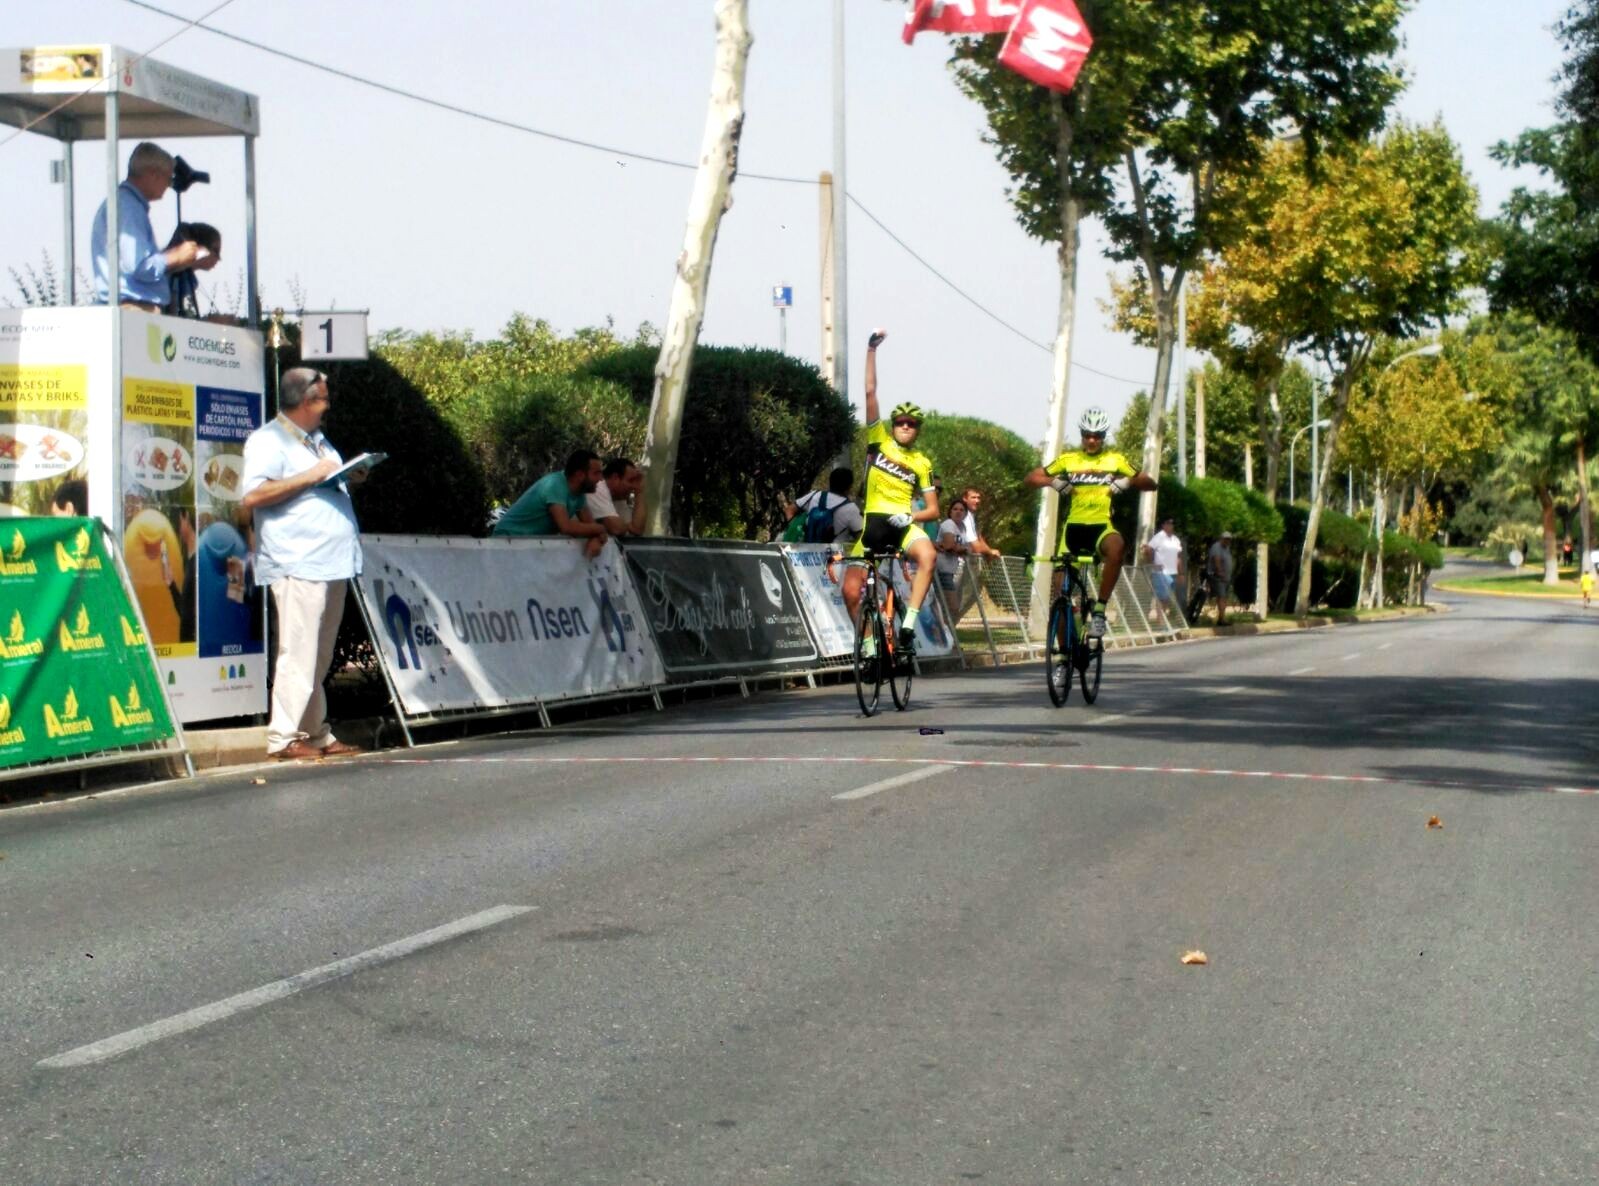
top-left (844, 329), bottom-right (940, 654)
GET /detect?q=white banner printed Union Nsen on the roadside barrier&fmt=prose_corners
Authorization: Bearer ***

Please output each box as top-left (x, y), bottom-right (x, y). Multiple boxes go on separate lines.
top-left (358, 535), bottom-right (665, 716)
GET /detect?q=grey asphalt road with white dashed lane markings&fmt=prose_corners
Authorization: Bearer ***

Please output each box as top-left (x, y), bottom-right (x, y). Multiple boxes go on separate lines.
top-left (0, 599), bottom-right (1599, 1186)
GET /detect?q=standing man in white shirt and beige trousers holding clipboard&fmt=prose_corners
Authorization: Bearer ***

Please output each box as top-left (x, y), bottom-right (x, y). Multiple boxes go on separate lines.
top-left (243, 366), bottom-right (366, 759)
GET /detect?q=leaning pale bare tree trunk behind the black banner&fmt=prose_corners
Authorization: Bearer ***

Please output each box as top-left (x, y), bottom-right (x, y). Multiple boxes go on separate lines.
top-left (644, 0), bottom-right (753, 535)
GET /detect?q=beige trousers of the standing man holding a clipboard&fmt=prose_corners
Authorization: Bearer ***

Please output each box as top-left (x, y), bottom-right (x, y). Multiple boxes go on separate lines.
top-left (267, 577), bottom-right (350, 753)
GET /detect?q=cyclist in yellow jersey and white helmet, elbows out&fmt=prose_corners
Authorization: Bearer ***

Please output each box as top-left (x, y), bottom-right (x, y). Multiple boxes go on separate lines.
top-left (1025, 408), bottom-right (1156, 638)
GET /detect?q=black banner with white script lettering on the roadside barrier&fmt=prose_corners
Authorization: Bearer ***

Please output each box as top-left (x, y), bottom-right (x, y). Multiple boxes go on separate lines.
top-left (625, 540), bottom-right (819, 679)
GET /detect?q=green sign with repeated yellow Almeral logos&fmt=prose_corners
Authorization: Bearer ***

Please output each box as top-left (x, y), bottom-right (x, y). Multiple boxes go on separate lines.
top-left (0, 518), bottom-right (174, 767)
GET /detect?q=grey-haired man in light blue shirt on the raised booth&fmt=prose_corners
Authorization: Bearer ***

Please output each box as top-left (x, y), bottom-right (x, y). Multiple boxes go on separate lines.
top-left (90, 141), bottom-right (217, 313)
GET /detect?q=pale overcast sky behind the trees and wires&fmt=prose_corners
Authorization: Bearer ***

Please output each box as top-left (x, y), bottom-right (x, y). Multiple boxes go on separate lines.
top-left (0, 0), bottom-right (1567, 440)
